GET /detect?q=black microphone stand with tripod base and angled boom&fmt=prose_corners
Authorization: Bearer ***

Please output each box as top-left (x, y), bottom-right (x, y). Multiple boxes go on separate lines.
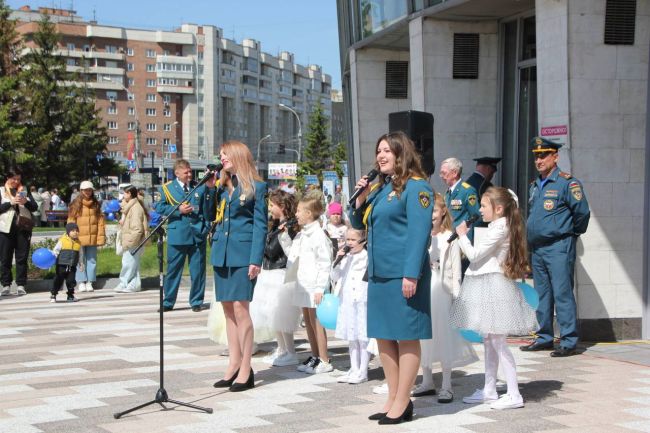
top-left (113, 171), bottom-right (214, 419)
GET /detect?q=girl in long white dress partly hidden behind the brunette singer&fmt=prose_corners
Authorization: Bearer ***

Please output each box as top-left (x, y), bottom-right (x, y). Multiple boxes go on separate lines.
top-left (412, 193), bottom-right (478, 403)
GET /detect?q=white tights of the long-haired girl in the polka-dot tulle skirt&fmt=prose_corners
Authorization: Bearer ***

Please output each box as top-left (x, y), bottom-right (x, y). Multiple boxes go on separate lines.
top-left (483, 334), bottom-right (520, 397)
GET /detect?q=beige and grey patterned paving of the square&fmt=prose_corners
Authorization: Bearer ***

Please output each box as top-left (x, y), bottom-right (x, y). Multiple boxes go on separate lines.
top-left (0, 288), bottom-right (650, 433)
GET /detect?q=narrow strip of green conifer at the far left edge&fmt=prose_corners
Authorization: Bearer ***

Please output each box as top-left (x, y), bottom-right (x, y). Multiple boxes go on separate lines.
top-left (0, 0), bottom-right (25, 169)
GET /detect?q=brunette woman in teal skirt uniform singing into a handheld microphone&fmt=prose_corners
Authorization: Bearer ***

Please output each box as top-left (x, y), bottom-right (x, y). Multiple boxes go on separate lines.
top-left (350, 132), bottom-right (433, 424)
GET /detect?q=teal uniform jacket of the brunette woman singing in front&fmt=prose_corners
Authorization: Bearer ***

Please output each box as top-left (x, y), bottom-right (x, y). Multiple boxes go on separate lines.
top-left (350, 179), bottom-right (433, 278)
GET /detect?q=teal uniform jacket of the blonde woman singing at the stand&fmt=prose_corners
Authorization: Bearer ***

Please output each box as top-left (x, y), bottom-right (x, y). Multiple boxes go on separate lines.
top-left (210, 181), bottom-right (268, 267)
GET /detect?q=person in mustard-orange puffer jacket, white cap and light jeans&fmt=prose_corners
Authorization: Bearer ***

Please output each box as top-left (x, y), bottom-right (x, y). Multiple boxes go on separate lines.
top-left (68, 180), bottom-right (106, 292)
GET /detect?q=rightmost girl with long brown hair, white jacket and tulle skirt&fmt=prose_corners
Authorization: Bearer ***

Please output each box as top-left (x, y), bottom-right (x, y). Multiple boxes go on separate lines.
top-left (451, 187), bottom-right (537, 409)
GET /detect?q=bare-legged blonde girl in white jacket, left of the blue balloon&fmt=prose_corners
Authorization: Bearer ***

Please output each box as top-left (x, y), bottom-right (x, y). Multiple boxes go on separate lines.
top-left (285, 192), bottom-right (334, 374)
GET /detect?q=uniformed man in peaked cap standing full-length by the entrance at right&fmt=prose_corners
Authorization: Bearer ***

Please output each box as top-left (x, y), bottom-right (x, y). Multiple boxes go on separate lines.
top-left (520, 137), bottom-right (590, 357)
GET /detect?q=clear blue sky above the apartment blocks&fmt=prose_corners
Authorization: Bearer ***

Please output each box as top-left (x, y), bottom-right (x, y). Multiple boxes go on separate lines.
top-left (6, 0), bottom-right (341, 89)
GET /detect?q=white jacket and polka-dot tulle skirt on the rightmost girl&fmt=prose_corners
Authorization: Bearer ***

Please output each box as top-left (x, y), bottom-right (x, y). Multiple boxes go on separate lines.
top-left (451, 218), bottom-right (538, 336)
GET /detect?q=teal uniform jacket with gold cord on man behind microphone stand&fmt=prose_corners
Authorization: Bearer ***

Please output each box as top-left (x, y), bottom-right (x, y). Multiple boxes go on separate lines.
top-left (154, 180), bottom-right (214, 245)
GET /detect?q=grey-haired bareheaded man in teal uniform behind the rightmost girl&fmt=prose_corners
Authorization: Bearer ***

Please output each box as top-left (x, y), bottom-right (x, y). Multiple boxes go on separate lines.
top-left (440, 158), bottom-right (481, 236)
